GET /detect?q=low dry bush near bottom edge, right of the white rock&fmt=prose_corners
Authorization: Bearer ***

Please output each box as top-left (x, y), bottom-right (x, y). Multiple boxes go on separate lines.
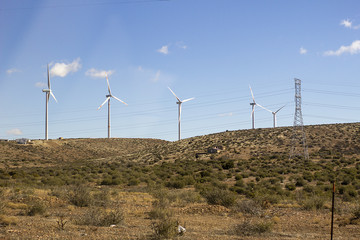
top-left (233, 219), bottom-right (273, 236)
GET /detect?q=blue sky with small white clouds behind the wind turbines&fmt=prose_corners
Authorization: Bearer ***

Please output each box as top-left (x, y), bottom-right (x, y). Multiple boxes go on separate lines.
top-left (0, 0), bottom-right (360, 140)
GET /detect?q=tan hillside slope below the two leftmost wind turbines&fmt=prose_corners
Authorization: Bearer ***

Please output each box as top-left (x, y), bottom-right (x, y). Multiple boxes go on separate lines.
top-left (0, 138), bottom-right (166, 167)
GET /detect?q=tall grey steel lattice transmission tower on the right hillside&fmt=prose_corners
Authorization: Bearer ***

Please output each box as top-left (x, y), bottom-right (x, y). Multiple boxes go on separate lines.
top-left (290, 78), bottom-right (309, 160)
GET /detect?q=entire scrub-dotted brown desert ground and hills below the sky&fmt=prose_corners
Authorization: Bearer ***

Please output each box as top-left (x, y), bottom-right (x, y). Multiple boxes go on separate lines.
top-left (0, 123), bottom-right (360, 240)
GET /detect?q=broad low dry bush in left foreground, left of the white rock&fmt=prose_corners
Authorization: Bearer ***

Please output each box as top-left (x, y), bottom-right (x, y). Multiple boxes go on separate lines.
top-left (75, 207), bottom-right (124, 226)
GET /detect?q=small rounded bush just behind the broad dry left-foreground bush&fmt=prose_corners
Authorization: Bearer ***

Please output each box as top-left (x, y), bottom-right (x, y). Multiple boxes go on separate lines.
top-left (67, 185), bottom-right (93, 207)
